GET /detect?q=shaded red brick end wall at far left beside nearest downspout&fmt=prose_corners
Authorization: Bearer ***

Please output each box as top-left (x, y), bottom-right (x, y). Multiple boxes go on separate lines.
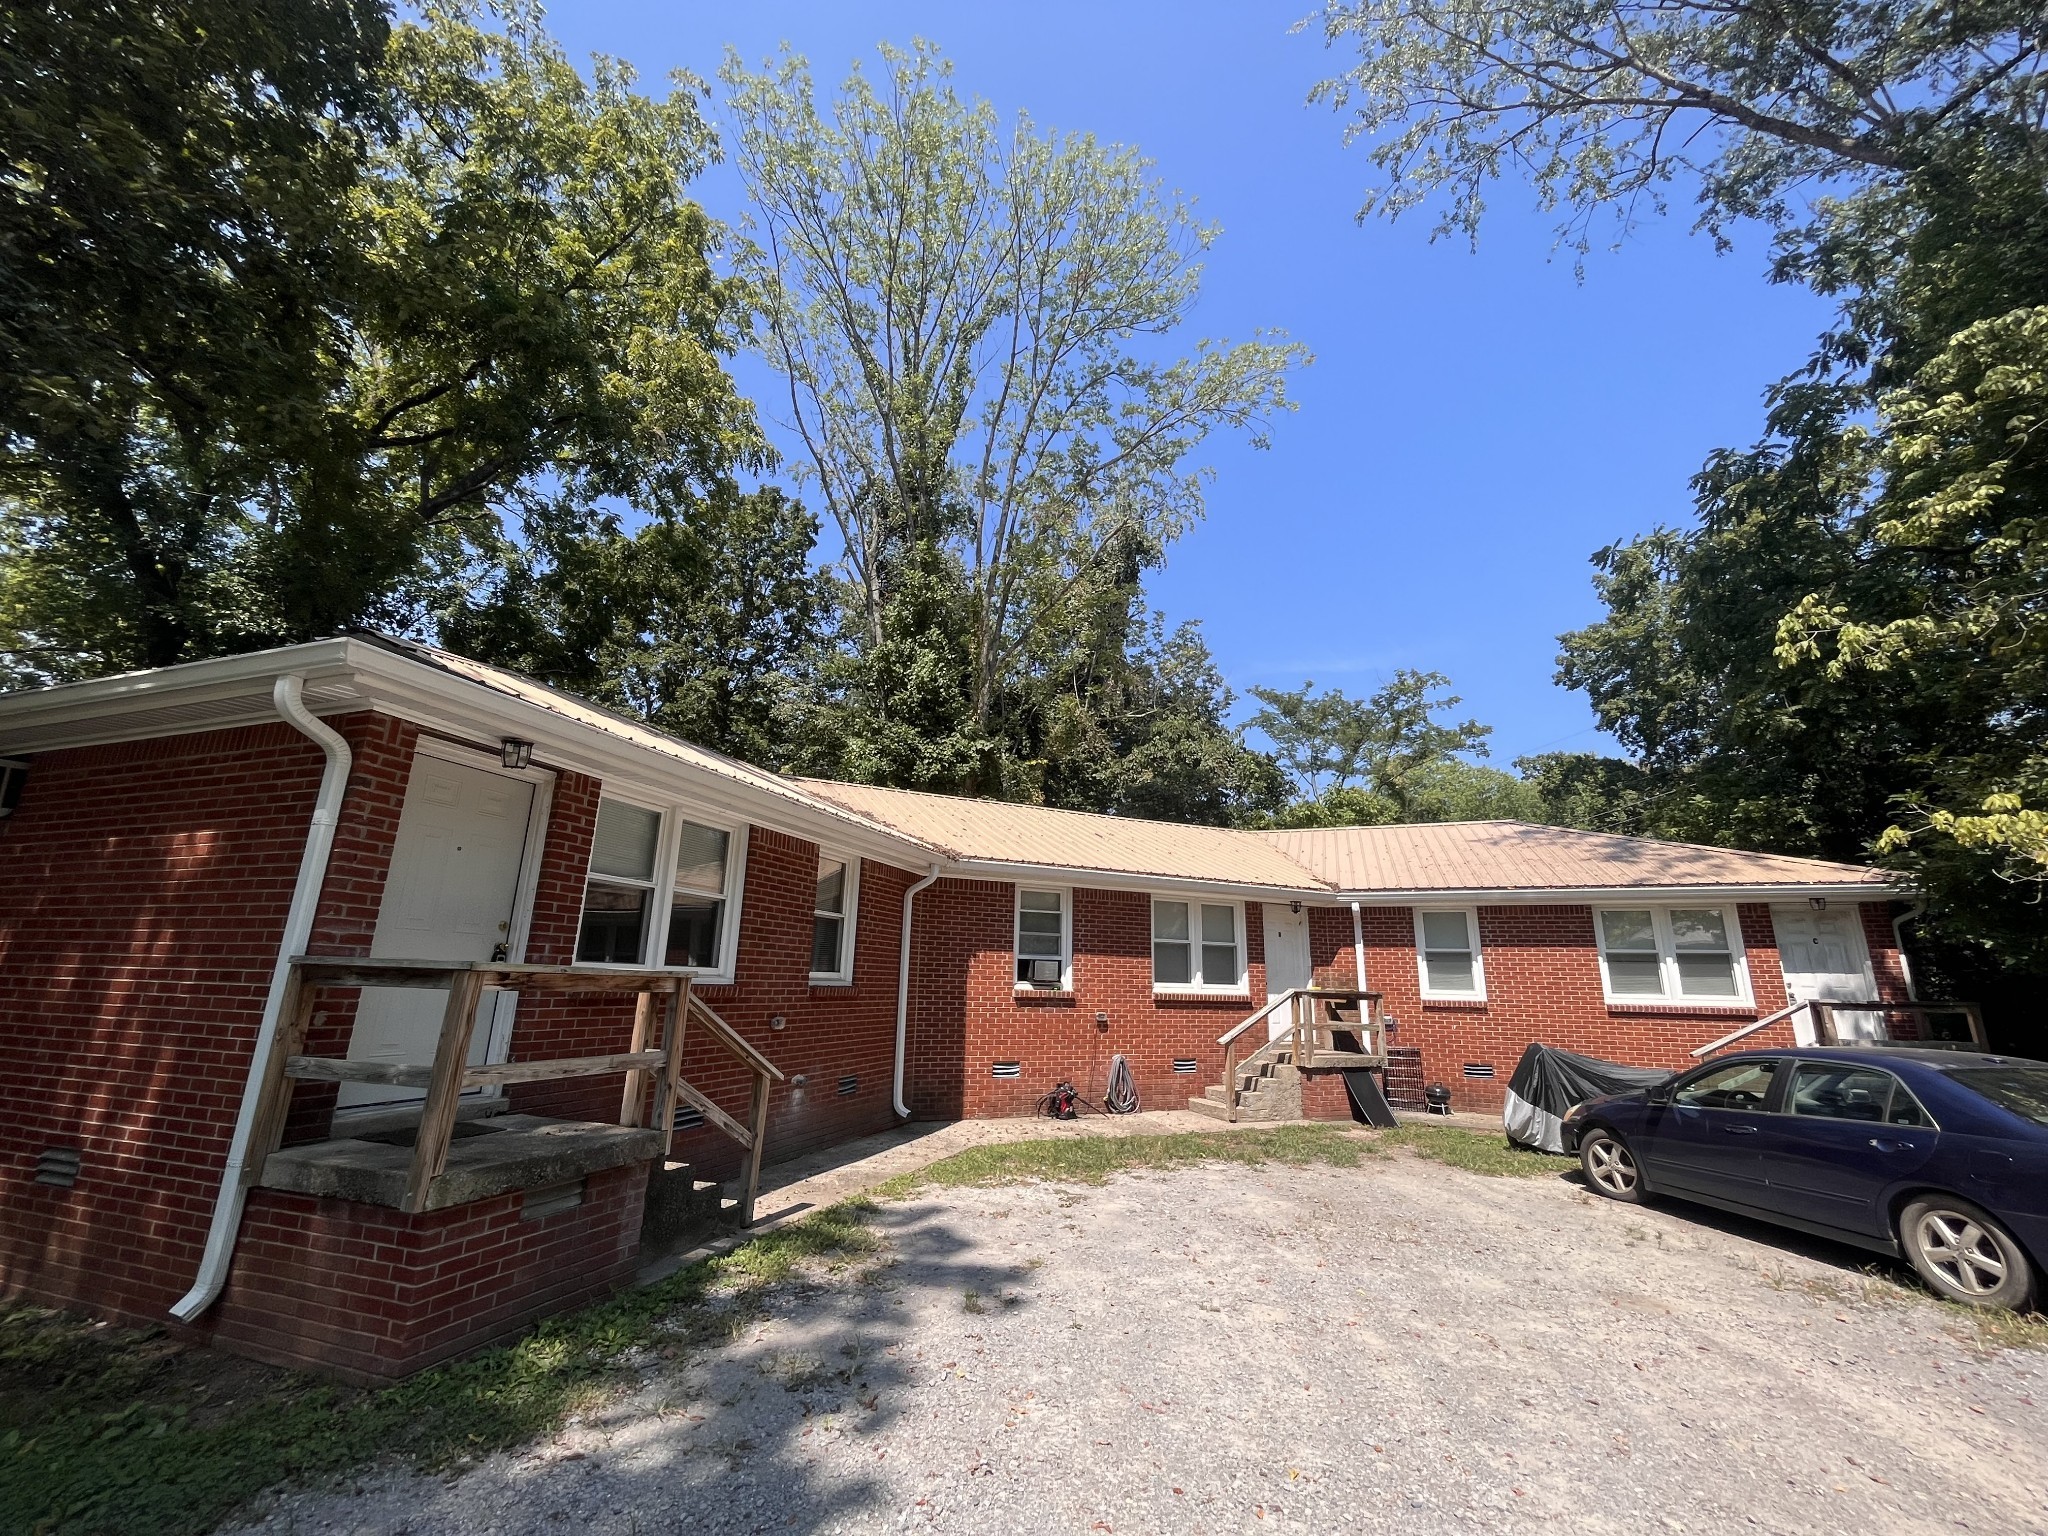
top-left (0, 715), bottom-right (393, 1321)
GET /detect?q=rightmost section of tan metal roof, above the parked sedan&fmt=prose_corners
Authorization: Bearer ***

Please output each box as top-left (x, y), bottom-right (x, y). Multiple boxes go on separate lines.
top-left (1247, 821), bottom-right (1890, 891)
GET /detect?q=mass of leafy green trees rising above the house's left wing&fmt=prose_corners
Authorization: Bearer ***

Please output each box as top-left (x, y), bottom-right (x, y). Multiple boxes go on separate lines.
top-left (0, 0), bottom-right (760, 678)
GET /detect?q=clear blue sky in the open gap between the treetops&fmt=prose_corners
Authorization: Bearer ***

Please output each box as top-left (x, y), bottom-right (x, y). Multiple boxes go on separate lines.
top-left (549, 0), bottom-right (1827, 766)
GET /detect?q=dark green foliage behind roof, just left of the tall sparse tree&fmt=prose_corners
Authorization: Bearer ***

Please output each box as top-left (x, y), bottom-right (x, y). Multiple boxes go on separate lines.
top-left (438, 487), bottom-right (829, 768)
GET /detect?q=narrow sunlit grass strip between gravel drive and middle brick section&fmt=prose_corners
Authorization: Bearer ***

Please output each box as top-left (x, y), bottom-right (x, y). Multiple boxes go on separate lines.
top-left (874, 1122), bottom-right (1372, 1200)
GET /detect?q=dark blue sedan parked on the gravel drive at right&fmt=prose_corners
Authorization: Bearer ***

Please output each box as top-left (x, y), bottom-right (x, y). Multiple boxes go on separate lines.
top-left (1565, 1047), bottom-right (2048, 1309)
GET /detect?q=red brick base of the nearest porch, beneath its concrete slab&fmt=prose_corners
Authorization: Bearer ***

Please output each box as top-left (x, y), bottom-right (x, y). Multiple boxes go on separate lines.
top-left (205, 1163), bottom-right (647, 1380)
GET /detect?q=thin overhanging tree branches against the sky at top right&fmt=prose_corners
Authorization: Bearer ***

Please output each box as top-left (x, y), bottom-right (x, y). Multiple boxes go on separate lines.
top-left (1315, 0), bottom-right (2044, 250)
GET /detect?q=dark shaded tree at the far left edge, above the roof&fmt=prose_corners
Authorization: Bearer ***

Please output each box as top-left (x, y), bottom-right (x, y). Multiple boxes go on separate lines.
top-left (0, 0), bottom-right (389, 682)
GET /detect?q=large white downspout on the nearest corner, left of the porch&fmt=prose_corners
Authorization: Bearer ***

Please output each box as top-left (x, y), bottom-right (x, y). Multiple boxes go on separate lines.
top-left (170, 674), bottom-right (350, 1323)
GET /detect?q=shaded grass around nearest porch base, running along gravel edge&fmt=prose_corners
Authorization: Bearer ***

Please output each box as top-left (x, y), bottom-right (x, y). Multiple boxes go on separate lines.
top-left (0, 1200), bottom-right (881, 1536)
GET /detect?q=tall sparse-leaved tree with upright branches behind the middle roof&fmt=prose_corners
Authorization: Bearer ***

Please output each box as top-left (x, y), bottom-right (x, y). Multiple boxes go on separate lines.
top-left (723, 43), bottom-right (1303, 793)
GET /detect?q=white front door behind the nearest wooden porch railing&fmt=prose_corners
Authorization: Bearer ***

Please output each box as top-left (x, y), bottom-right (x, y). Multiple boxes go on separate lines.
top-left (340, 752), bottom-right (535, 1108)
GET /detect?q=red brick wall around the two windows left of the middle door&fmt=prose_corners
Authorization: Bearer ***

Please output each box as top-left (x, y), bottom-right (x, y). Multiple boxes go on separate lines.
top-left (905, 879), bottom-right (1266, 1120)
